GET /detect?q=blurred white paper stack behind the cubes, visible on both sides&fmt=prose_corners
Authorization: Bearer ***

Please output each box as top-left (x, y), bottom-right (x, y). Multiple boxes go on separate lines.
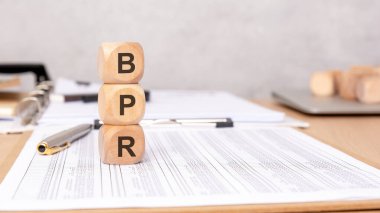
top-left (42, 90), bottom-right (284, 122)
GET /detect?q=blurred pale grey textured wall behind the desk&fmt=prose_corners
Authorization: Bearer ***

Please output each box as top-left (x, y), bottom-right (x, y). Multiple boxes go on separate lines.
top-left (0, 0), bottom-right (380, 98)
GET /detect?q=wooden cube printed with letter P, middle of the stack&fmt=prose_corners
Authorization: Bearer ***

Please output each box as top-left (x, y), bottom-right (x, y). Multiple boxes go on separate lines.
top-left (98, 84), bottom-right (145, 125)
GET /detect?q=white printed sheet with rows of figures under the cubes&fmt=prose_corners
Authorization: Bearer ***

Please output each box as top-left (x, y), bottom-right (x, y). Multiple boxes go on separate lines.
top-left (0, 126), bottom-right (380, 210)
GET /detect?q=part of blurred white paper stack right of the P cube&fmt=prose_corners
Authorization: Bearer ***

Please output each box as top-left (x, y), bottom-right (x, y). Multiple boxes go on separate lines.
top-left (145, 90), bottom-right (284, 122)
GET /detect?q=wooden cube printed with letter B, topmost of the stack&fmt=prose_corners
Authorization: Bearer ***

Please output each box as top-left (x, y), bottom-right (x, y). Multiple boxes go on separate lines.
top-left (98, 42), bottom-right (144, 84)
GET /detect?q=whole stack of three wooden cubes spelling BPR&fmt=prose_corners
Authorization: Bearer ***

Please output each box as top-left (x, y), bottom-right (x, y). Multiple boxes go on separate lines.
top-left (98, 42), bottom-right (145, 164)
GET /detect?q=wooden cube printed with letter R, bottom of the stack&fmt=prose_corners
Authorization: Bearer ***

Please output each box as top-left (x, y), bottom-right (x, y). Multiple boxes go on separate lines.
top-left (98, 124), bottom-right (145, 165)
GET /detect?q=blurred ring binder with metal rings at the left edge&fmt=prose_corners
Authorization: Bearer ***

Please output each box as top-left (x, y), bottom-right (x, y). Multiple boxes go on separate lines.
top-left (0, 63), bottom-right (53, 120)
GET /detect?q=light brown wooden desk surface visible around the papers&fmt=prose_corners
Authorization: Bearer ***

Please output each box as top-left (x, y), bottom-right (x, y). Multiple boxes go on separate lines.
top-left (0, 101), bottom-right (380, 212)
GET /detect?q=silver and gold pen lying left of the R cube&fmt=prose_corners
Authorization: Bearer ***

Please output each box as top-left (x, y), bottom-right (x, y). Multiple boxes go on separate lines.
top-left (37, 124), bottom-right (92, 155)
